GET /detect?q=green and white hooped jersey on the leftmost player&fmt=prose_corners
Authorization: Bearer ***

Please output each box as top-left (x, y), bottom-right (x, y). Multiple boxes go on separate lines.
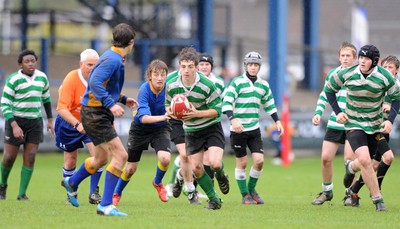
top-left (1, 70), bottom-right (50, 120)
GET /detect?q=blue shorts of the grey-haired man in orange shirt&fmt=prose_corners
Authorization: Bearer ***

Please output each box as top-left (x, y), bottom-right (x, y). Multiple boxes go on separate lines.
top-left (54, 115), bottom-right (92, 152)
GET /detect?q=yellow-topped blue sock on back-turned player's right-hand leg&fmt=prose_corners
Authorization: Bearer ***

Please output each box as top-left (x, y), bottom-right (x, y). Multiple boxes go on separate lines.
top-left (100, 164), bottom-right (122, 206)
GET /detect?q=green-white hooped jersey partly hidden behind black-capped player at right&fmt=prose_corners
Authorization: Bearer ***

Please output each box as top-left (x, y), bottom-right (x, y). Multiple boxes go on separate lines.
top-left (314, 66), bottom-right (346, 130)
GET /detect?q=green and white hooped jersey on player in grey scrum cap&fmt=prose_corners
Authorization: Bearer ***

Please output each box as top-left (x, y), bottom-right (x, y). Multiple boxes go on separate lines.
top-left (222, 73), bottom-right (277, 131)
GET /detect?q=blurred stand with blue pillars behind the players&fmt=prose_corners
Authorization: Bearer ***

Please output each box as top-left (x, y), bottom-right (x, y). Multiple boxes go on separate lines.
top-left (0, 0), bottom-right (400, 155)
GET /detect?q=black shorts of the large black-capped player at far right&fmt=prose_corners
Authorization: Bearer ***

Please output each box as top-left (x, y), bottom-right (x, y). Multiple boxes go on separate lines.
top-left (346, 130), bottom-right (380, 158)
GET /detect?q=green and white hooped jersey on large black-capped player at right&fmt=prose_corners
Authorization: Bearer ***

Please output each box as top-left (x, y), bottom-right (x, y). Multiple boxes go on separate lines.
top-left (324, 65), bottom-right (400, 134)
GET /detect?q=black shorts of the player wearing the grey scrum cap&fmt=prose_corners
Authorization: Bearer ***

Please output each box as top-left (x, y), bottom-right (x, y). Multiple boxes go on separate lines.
top-left (230, 128), bottom-right (264, 158)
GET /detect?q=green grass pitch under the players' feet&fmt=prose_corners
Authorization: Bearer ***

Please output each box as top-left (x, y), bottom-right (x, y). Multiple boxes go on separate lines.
top-left (0, 153), bottom-right (400, 229)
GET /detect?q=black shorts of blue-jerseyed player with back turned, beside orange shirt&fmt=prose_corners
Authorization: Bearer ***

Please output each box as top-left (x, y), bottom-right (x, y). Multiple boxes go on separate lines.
top-left (81, 106), bottom-right (118, 146)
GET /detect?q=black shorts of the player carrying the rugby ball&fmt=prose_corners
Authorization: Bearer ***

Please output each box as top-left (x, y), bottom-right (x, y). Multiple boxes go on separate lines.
top-left (185, 122), bottom-right (225, 155)
